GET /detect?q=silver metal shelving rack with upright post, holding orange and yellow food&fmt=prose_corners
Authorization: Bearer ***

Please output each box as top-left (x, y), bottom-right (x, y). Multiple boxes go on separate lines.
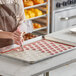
top-left (22, 0), bottom-right (50, 35)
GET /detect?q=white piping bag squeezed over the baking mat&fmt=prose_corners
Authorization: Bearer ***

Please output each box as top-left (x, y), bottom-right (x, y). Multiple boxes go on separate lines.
top-left (17, 20), bottom-right (33, 51)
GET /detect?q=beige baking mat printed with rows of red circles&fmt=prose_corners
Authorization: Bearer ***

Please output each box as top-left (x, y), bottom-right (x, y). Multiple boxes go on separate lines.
top-left (2, 38), bottom-right (75, 63)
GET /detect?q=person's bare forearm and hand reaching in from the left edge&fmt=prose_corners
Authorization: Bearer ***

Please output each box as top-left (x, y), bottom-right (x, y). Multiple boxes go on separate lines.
top-left (0, 30), bottom-right (21, 45)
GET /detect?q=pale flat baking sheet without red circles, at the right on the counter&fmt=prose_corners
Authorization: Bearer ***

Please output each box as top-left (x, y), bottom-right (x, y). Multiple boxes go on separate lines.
top-left (45, 28), bottom-right (76, 46)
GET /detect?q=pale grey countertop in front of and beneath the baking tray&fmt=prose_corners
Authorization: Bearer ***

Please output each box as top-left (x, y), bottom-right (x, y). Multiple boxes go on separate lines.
top-left (0, 26), bottom-right (76, 76)
